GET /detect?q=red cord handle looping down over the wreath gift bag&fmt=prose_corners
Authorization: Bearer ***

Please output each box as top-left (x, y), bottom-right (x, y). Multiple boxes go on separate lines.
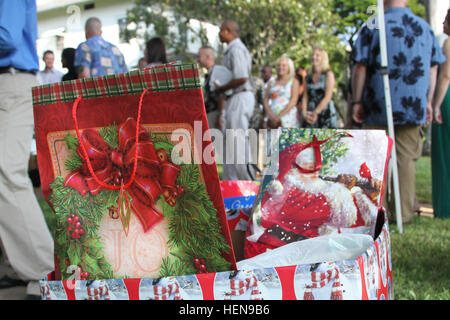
top-left (72, 89), bottom-right (148, 190)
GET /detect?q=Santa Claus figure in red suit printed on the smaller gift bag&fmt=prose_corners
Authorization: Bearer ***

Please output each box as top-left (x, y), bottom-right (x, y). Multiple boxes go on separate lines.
top-left (245, 136), bottom-right (378, 258)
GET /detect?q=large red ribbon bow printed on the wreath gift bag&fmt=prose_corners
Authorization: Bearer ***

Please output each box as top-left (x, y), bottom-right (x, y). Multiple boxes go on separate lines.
top-left (64, 118), bottom-right (183, 232)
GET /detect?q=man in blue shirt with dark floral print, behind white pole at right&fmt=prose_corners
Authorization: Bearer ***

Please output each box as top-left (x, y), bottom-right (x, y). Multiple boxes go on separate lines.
top-left (351, 0), bottom-right (446, 223)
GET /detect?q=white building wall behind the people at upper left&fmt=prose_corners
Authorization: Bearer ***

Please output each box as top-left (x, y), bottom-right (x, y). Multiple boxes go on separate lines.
top-left (37, 0), bottom-right (220, 72)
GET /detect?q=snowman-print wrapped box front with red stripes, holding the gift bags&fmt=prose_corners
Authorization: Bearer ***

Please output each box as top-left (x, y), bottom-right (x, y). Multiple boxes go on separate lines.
top-left (40, 210), bottom-right (394, 300)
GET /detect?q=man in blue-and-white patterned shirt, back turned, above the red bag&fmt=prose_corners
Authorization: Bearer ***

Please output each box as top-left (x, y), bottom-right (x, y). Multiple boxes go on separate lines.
top-left (75, 17), bottom-right (128, 78)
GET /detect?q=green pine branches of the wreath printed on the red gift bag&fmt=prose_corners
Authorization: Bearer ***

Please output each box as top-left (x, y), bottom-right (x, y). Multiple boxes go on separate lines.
top-left (50, 124), bottom-right (230, 280)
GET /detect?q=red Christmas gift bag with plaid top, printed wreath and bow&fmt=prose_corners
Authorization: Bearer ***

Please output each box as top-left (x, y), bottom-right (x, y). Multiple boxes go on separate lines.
top-left (33, 65), bottom-right (236, 282)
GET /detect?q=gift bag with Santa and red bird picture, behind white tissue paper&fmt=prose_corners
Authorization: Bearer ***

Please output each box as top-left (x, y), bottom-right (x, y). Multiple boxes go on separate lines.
top-left (244, 129), bottom-right (392, 258)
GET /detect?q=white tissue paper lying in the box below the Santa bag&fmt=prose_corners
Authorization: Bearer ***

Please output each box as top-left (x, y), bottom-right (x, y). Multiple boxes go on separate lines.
top-left (237, 233), bottom-right (373, 270)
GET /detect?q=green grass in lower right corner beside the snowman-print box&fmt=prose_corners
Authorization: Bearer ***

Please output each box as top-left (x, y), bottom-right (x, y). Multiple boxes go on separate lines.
top-left (390, 216), bottom-right (450, 300)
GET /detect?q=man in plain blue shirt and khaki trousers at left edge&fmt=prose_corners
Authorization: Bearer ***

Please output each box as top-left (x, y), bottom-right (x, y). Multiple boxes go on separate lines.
top-left (0, 0), bottom-right (54, 297)
